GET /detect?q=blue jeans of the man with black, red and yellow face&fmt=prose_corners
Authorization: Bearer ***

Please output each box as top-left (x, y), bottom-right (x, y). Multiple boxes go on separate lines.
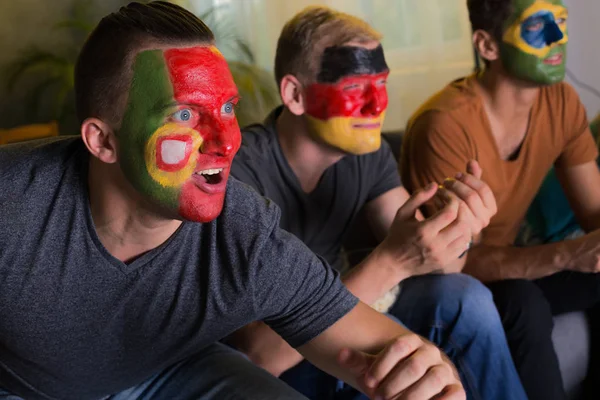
top-left (281, 274), bottom-right (527, 400)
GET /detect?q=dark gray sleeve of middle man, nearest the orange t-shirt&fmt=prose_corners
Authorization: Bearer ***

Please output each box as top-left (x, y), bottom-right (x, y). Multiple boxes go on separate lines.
top-left (363, 139), bottom-right (402, 202)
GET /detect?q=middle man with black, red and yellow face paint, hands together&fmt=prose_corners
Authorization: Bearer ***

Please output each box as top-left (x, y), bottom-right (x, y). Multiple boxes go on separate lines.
top-left (231, 7), bottom-right (525, 400)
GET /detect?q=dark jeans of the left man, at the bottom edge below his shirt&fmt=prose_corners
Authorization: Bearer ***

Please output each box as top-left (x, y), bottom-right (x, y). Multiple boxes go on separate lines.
top-left (0, 343), bottom-right (306, 400)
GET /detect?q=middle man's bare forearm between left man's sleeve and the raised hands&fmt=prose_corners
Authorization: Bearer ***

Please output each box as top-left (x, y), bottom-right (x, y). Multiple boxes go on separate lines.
top-left (342, 246), bottom-right (410, 304)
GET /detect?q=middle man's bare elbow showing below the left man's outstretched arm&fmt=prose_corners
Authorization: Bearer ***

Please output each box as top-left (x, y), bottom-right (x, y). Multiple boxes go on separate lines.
top-left (228, 322), bottom-right (304, 377)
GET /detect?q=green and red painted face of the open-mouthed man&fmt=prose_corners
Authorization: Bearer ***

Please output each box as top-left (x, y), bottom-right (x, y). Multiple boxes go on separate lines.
top-left (118, 46), bottom-right (241, 222)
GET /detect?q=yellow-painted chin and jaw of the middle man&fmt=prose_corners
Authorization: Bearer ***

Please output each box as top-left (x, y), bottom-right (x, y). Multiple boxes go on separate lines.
top-left (306, 112), bottom-right (385, 155)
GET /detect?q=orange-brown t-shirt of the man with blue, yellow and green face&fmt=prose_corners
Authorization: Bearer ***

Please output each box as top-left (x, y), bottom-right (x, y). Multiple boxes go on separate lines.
top-left (400, 76), bottom-right (598, 246)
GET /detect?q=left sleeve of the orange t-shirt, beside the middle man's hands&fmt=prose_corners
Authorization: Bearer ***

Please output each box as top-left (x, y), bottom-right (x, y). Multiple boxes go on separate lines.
top-left (400, 111), bottom-right (476, 216)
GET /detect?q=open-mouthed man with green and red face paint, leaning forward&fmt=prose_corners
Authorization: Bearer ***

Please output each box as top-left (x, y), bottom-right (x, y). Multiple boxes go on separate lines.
top-left (0, 1), bottom-right (464, 400)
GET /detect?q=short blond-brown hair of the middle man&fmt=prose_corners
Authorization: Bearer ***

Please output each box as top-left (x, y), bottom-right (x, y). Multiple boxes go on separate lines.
top-left (275, 6), bottom-right (381, 85)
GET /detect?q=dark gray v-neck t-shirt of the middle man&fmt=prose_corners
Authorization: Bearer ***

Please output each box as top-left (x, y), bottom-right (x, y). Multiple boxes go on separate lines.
top-left (231, 107), bottom-right (401, 269)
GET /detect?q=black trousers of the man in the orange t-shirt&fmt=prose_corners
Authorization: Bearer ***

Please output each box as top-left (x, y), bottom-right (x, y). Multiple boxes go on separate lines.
top-left (489, 272), bottom-right (600, 400)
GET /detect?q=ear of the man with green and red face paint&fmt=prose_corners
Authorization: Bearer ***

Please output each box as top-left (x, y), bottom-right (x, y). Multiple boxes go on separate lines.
top-left (81, 118), bottom-right (117, 164)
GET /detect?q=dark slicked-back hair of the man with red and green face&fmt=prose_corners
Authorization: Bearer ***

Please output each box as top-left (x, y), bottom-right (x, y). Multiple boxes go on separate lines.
top-left (75, 1), bottom-right (214, 128)
